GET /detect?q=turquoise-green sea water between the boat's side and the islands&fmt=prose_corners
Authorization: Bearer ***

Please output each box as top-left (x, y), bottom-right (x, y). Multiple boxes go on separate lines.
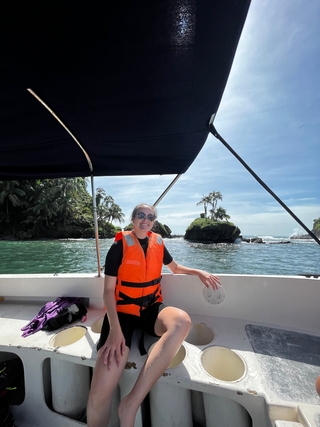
top-left (0, 236), bottom-right (320, 275)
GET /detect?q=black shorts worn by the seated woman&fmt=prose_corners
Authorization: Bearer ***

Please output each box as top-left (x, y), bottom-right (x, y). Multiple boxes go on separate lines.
top-left (97, 302), bottom-right (167, 351)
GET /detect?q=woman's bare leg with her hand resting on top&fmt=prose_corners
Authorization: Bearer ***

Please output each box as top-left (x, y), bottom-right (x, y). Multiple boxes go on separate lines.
top-left (87, 347), bottom-right (130, 427)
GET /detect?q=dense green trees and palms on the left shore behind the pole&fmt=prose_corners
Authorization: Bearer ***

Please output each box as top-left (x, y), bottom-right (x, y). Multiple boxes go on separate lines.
top-left (0, 178), bottom-right (124, 239)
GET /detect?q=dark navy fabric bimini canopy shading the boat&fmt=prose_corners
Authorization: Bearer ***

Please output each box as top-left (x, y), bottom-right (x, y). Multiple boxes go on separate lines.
top-left (0, 0), bottom-right (250, 180)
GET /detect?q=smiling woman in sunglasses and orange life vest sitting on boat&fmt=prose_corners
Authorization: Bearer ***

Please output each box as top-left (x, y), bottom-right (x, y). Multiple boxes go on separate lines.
top-left (87, 204), bottom-right (220, 427)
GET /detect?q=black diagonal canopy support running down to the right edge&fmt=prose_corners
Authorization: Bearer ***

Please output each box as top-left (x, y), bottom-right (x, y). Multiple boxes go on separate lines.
top-left (209, 122), bottom-right (320, 245)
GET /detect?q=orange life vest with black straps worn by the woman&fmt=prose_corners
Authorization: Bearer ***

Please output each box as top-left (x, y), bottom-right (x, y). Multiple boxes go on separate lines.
top-left (115, 231), bottom-right (164, 316)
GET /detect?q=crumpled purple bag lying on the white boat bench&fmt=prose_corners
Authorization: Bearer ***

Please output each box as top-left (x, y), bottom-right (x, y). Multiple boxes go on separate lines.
top-left (21, 297), bottom-right (80, 338)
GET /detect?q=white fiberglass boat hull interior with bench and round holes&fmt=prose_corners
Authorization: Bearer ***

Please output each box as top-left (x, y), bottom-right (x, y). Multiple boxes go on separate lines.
top-left (0, 274), bottom-right (320, 427)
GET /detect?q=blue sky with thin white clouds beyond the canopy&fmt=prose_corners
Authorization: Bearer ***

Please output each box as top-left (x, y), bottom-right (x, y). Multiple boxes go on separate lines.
top-left (90, 0), bottom-right (320, 237)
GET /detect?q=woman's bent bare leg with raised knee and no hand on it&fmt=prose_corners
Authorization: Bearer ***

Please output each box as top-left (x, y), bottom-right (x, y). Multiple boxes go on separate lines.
top-left (119, 307), bottom-right (191, 427)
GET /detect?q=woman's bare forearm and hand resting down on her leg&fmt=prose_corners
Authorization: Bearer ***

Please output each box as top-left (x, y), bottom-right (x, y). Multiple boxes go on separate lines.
top-left (98, 276), bottom-right (126, 369)
